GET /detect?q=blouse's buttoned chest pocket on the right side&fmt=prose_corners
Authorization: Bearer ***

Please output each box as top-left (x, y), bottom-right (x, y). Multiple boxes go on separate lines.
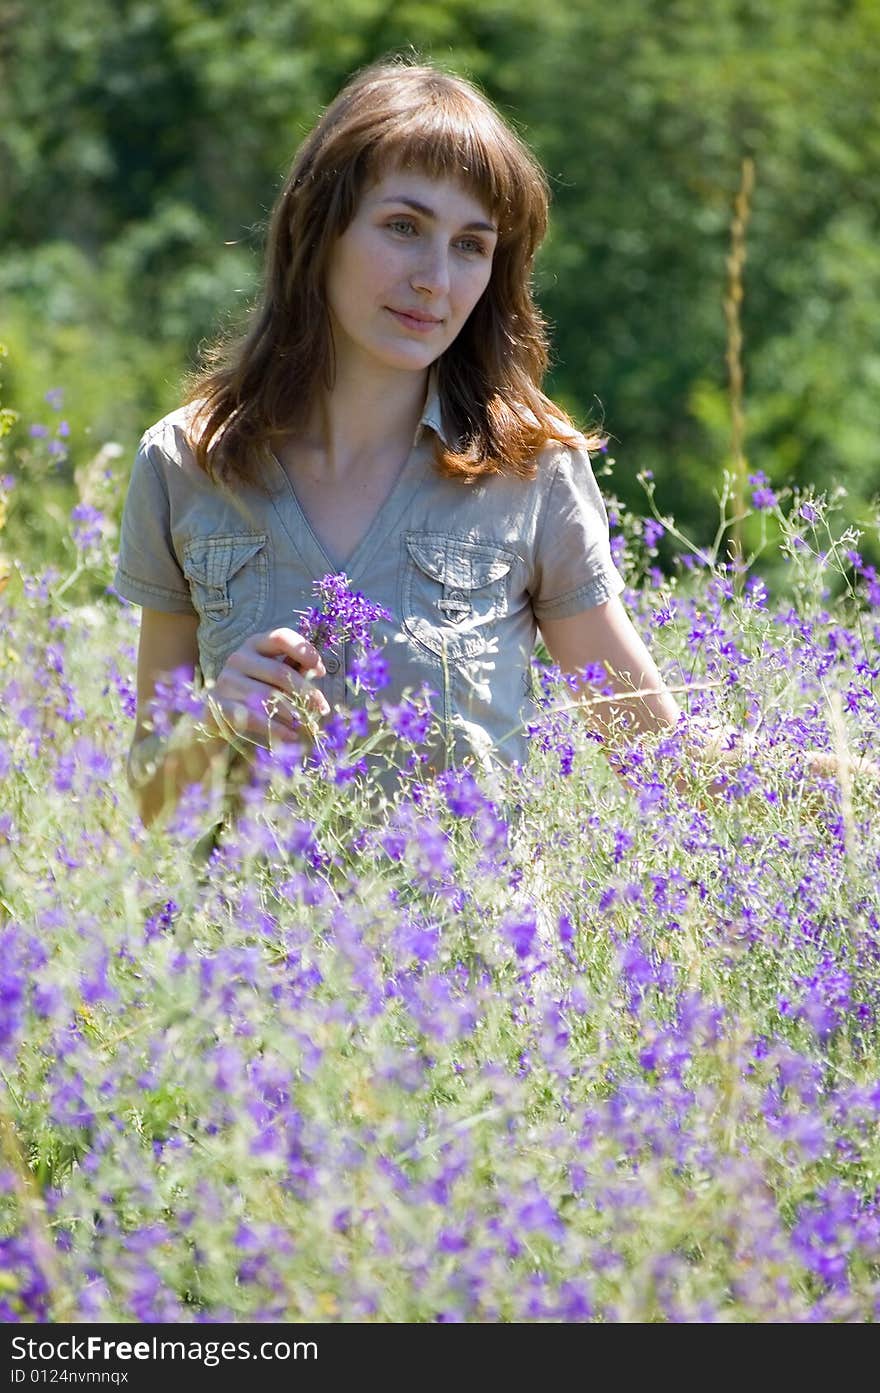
top-left (401, 532), bottom-right (515, 663)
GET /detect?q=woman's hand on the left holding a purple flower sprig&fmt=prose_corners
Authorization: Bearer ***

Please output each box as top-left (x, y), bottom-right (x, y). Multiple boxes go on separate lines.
top-left (209, 628), bottom-right (330, 744)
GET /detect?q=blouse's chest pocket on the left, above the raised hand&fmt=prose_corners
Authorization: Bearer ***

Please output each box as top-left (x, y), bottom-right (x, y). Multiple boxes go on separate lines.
top-left (184, 532), bottom-right (269, 656)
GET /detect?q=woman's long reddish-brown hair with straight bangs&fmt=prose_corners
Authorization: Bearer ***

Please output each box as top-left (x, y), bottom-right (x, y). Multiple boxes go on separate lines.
top-left (188, 59), bottom-right (599, 482)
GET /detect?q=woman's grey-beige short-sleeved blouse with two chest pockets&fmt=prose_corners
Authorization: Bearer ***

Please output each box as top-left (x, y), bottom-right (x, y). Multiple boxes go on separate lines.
top-left (114, 378), bottom-right (624, 768)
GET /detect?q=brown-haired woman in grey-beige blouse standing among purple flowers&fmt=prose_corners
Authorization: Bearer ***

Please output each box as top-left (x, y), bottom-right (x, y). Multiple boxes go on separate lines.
top-left (116, 63), bottom-right (678, 822)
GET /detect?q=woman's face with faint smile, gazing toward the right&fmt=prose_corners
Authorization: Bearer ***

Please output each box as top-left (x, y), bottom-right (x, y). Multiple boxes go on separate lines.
top-left (326, 170), bottom-right (497, 381)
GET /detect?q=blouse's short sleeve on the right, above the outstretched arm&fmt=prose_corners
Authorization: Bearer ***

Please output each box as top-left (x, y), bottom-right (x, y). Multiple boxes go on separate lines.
top-left (532, 449), bottom-right (624, 621)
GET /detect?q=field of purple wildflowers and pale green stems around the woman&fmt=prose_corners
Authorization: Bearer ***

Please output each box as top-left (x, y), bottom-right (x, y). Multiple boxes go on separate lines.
top-left (0, 409), bottom-right (880, 1322)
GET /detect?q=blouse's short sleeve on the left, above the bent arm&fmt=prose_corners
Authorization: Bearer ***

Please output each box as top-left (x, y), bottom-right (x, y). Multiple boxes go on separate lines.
top-left (113, 437), bottom-right (195, 614)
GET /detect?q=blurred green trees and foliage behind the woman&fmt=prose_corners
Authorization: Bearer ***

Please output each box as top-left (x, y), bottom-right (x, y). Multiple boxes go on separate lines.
top-left (0, 0), bottom-right (880, 568)
